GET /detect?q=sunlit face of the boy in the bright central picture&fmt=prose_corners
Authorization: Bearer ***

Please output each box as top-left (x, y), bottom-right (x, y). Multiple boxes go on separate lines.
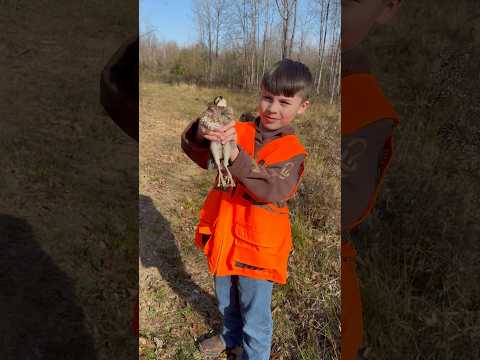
top-left (258, 88), bottom-right (310, 130)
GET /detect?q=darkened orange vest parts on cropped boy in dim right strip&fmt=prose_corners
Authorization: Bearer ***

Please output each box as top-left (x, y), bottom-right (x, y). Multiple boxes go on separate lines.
top-left (341, 74), bottom-right (399, 360)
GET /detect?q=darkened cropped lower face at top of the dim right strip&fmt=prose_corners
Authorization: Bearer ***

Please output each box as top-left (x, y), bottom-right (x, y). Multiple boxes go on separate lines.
top-left (342, 0), bottom-right (401, 50)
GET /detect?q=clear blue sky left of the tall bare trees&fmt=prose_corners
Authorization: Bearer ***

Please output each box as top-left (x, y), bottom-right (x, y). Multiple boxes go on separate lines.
top-left (140, 0), bottom-right (198, 45)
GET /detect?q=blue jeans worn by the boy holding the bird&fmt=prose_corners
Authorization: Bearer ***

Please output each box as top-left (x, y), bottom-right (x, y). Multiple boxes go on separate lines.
top-left (214, 275), bottom-right (273, 360)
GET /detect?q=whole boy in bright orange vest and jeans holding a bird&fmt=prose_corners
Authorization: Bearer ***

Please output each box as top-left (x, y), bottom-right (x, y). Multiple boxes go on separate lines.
top-left (182, 59), bottom-right (312, 360)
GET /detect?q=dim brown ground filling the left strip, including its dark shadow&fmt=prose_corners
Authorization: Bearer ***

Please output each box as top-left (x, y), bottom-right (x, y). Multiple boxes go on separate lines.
top-left (0, 0), bottom-right (138, 360)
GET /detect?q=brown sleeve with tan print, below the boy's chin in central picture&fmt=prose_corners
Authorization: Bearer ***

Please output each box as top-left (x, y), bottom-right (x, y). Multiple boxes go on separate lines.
top-left (228, 145), bottom-right (305, 203)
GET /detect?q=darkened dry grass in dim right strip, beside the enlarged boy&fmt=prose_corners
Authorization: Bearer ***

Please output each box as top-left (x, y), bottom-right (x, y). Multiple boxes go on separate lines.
top-left (357, 0), bottom-right (480, 360)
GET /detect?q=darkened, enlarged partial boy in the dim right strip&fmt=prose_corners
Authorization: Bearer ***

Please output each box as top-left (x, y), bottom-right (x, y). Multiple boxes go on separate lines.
top-left (341, 0), bottom-right (400, 360)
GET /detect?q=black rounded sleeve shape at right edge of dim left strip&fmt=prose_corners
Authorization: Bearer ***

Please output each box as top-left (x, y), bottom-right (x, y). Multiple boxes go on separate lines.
top-left (100, 37), bottom-right (139, 141)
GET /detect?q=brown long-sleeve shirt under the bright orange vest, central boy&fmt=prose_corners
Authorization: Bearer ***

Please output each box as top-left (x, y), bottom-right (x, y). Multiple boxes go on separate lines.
top-left (181, 118), bottom-right (305, 205)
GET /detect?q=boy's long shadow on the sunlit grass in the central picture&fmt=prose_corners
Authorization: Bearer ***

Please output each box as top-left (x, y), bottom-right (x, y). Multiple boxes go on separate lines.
top-left (139, 195), bottom-right (220, 331)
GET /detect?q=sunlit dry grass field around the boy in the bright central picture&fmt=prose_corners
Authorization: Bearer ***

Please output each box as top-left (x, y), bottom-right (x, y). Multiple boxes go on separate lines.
top-left (139, 82), bottom-right (340, 360)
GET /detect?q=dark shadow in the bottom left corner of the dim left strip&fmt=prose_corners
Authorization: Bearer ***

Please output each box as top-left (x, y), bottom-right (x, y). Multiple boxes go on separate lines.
top-left (0, 214), bottom-right (97, 360)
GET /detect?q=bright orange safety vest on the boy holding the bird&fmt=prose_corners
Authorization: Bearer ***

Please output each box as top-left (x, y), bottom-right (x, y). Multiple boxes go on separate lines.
top-left (195, 122), bottom-right (307, 284)
